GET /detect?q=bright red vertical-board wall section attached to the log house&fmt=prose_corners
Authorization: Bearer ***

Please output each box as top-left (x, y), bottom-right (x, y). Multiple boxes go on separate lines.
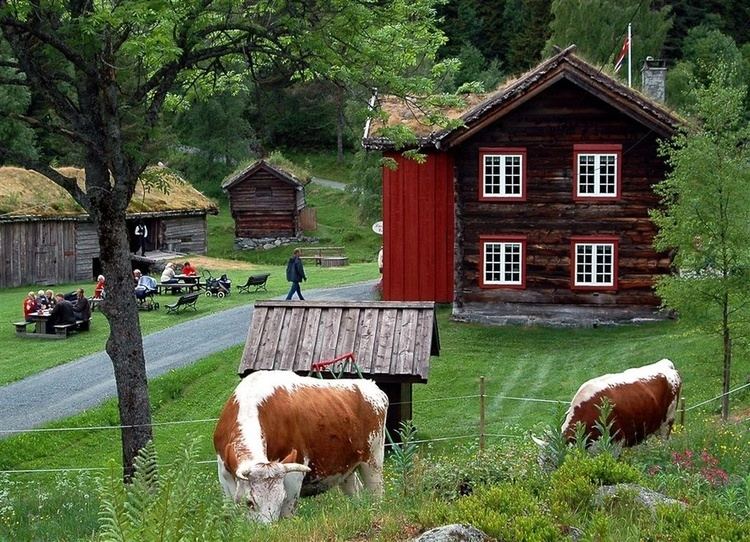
top-left (383, 153), bottom-right (455, 303)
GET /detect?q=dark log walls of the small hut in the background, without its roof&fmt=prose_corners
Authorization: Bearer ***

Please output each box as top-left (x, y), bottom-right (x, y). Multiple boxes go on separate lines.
top-left (229, 169), bottom-right (299, 238)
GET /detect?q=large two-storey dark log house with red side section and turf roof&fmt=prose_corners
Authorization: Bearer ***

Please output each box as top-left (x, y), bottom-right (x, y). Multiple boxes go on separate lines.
top-left (363, 47), bottom-right (682, 325)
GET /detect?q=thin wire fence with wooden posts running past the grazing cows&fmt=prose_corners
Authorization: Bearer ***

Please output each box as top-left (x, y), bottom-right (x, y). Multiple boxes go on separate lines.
top-left (0, 377), bottom-right (750, 475)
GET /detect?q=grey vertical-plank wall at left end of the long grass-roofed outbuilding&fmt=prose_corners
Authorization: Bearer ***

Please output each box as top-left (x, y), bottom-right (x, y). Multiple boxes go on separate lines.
top-left (0, 220), bottom-right (76, 287)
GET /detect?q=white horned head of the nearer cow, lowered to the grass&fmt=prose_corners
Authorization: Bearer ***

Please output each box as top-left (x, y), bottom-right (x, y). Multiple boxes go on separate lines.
top-left (234, 450), bottom-right (310, 523)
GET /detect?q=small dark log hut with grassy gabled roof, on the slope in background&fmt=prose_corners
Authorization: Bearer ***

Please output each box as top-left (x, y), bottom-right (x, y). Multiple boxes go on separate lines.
top-left (221, 160), bottom-right (306, 239)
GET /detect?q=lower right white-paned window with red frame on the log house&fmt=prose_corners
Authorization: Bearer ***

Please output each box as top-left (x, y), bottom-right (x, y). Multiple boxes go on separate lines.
top-left (572, 239), bottom-right (618, 288)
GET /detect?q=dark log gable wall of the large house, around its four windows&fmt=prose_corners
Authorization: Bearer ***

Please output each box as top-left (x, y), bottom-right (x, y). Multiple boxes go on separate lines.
top-left (454, 81), bottom-right (670, 316)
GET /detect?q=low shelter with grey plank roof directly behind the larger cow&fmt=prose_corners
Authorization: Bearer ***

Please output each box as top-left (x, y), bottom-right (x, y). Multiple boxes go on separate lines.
top-left (238, 301), bottom-right (440, 434)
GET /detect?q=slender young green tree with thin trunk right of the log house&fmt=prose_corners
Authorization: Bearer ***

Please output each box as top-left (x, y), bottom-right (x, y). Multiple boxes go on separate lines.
top-left (651, 64), bottom-right (750, 418)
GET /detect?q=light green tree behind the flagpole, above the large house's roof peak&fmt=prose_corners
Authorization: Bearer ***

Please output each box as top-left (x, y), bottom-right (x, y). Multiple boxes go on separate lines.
top-left (545, 0), bottom-right (672, 82)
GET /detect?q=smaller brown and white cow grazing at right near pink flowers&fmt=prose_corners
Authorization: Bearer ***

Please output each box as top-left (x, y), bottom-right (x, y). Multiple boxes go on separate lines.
top-left (561, 359), bottom-right (682, 446)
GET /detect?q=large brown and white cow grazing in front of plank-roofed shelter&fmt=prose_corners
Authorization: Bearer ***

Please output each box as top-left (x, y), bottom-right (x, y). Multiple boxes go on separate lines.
top-left (214, 371), bottom-right (388, 523)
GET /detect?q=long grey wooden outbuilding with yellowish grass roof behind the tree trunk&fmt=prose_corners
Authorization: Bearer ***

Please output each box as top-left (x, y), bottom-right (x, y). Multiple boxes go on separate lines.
top-left (0, 167), bottom-right (218, 287)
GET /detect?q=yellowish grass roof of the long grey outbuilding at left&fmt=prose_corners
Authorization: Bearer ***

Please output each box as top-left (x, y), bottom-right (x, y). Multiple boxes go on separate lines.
top-left (0, 167), bottom-right (218, 218)
